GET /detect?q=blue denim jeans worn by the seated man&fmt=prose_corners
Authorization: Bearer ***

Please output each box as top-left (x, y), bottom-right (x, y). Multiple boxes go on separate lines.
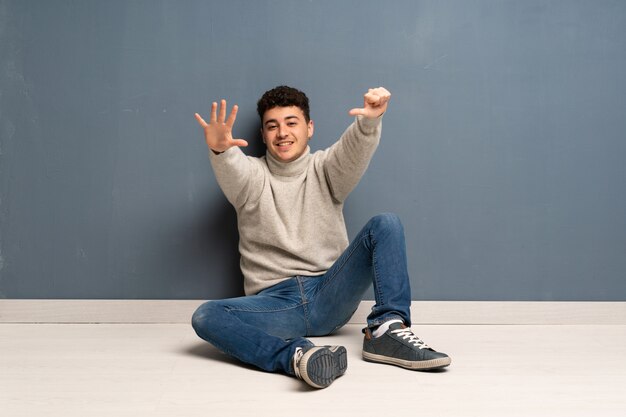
top-left (192, 213), bottom-right (411, 375)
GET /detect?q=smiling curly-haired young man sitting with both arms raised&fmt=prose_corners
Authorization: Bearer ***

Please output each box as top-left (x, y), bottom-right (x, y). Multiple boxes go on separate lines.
top-left (192, 86), bottom-right (450, 388)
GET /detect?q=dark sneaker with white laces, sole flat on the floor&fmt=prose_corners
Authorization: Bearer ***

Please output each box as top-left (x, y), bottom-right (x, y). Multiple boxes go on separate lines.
top-left (363, 323), bottom-right (451, 371)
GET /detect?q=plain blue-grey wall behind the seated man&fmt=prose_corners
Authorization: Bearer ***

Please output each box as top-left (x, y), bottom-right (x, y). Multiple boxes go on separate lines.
top-left (0, 0), bottom-right (626, 300)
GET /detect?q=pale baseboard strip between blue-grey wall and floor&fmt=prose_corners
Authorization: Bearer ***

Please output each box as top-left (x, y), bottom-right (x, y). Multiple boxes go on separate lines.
top-left (0, 299), bottom-right (626, 325)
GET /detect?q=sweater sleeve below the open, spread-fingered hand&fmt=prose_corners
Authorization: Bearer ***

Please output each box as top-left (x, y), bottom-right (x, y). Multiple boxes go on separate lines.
top-left (209, 146), bottom-right (264, 209)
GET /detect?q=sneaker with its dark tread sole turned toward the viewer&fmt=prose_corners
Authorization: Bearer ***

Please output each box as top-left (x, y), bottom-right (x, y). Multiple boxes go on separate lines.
top-left (293, 346), bottom-right (348, 388)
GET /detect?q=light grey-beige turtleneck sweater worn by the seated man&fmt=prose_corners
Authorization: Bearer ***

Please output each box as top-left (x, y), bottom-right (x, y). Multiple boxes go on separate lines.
top-left (209, 116), bottom-right (382, 295)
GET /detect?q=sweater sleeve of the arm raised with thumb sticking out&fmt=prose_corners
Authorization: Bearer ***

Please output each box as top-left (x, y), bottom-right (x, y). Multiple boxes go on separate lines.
top-left (324, 116), bottom-right (382, 202)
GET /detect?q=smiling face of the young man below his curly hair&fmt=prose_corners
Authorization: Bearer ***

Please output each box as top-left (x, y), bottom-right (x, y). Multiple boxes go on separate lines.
top-left (261, 106), bottom-right (313, 162)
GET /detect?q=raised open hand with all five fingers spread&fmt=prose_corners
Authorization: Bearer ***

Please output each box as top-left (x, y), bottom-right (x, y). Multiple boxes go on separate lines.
top-left (195, 100), bottom-right (248, 153)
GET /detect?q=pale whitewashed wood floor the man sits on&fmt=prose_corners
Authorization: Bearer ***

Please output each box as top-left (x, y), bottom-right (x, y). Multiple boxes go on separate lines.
top-left (0, 324), bottom-right (626, 417)
